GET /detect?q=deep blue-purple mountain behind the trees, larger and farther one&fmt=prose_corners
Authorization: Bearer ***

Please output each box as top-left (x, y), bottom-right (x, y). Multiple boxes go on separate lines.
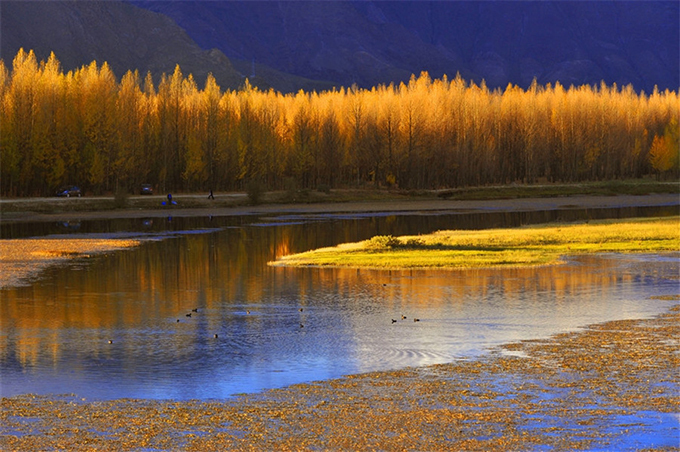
top-left (134, 1), bottom-right (680, 91)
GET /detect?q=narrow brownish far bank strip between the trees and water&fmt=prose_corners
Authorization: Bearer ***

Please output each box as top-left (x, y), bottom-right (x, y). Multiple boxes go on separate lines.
top-left (2, 193), bottom-right (680, 223)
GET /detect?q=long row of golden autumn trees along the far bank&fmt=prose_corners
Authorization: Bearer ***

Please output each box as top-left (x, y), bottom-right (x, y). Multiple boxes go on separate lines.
top-left (0, 50), bottom-right (680, 196)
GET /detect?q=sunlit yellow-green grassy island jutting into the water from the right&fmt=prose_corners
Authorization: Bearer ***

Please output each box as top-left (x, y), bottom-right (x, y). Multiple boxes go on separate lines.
top-left (270, 216), bottom-right (680, 269)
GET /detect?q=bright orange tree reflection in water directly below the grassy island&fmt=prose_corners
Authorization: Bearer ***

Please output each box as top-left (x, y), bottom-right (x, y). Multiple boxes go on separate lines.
top-left (276, 256), bottom-right (635, 307)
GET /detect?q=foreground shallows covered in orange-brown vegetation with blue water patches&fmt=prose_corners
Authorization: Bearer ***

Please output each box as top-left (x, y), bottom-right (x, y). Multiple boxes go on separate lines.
top-left (0, 304), bottom-right (680, 451)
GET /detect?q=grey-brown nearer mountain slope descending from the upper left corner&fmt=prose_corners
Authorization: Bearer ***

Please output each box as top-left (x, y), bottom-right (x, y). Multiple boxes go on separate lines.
top-left (0, 0), bottom-right (329, 91)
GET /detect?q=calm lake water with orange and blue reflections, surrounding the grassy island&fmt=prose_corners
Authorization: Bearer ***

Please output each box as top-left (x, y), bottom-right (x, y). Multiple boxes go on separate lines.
top-left (0, 208), bottom-right (680, 399)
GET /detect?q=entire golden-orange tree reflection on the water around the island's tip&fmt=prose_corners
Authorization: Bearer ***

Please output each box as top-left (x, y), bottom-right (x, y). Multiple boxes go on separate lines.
top-left (0, 223), bottom-right (668, 366)
